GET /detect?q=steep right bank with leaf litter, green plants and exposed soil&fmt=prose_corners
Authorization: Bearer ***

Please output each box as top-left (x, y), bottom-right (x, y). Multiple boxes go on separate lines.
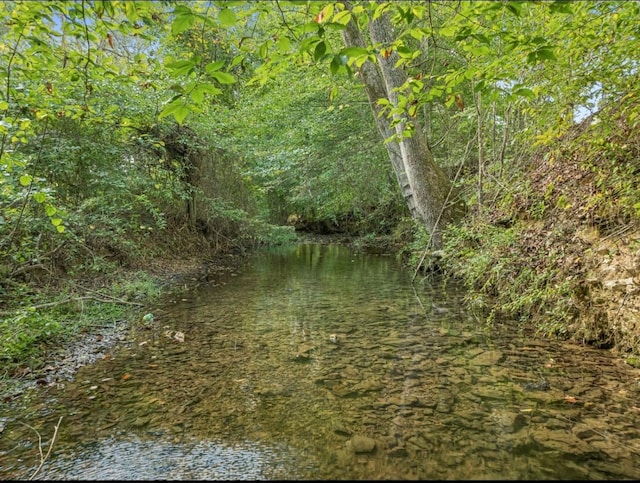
top-left (412, 93), bottom-right (640, 365)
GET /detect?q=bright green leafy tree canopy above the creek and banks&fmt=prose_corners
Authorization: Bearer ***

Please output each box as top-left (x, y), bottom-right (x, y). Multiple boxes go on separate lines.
top-left (0, 0), bottom-right (640, 280)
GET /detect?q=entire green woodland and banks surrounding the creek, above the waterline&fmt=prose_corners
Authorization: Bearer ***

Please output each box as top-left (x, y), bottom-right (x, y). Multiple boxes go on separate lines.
top-left (0, 0), bottom-right (640, 370)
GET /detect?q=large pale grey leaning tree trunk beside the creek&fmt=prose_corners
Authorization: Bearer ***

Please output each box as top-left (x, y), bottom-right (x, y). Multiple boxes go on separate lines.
top-left (342, 6), bottom-right (456, 248)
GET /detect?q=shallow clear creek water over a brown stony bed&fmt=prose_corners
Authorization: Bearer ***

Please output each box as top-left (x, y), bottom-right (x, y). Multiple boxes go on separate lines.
top-left (0, 244), bottom-right (640, 480)
